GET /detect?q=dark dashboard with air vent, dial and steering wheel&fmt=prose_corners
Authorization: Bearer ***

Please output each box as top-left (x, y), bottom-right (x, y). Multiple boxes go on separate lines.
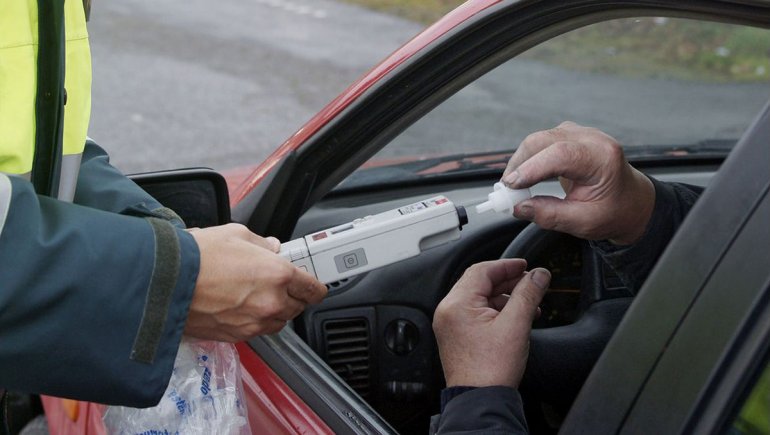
top-left (294, 167), bottom-right (715, 433)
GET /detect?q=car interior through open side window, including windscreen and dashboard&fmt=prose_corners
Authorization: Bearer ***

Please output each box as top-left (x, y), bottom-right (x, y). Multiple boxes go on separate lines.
top-left (237, 10), bottom-right (769, 433)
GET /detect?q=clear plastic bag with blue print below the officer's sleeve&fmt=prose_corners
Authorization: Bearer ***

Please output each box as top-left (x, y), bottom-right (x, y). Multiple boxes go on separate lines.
top-left (104, 337), bottom-right (251, 435)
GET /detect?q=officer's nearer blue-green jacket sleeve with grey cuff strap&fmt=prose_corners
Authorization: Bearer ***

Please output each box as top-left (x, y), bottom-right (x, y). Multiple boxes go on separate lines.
top-left (0, 174), bottom-right (200, 407)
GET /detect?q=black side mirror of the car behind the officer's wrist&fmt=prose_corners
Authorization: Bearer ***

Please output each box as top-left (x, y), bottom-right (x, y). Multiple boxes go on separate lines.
top-left (129, 168), bottom-right (230, 228)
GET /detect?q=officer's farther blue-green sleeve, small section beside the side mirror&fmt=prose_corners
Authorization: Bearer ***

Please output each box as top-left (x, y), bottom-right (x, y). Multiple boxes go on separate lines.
top-left (74, 139), bottom-right (184, 228)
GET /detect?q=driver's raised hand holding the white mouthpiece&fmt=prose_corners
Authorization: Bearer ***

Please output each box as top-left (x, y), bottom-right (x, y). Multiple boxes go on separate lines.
top-left (502, 122), bottom-right (655, 245)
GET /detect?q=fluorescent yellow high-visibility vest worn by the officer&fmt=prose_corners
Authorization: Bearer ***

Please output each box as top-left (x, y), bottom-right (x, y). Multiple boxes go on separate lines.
top-left (0, 0), bottom-right (91, 199)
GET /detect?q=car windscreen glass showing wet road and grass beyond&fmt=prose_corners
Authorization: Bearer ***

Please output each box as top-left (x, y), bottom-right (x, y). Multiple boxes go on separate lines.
top-left (344, 17), bottom-right (770, 187)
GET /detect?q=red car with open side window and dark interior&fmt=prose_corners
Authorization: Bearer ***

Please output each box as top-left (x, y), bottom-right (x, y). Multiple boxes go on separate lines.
top-left (37, 0), bottom-right (770, 434)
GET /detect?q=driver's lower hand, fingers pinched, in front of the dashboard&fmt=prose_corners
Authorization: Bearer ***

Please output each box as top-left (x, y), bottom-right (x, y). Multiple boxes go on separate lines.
top-left (433, 259), bottom-right (551, 388)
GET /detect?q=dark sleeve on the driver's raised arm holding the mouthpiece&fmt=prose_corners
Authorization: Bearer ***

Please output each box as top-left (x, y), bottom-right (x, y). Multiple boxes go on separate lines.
top-left (590, 177), bottom-right (703, 294)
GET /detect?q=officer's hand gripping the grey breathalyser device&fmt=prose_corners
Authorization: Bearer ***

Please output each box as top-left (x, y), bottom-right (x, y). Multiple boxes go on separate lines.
top-left (185, 224), bottom-right (327, 342)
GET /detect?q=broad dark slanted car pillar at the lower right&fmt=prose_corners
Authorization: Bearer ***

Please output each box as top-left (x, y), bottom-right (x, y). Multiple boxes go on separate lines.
top-left (563, 101), bottom-right (770, 434)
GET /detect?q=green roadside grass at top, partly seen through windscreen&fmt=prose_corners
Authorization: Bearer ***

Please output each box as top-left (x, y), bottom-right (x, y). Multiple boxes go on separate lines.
top-left (345, 0), bottom-right (770, 82)
